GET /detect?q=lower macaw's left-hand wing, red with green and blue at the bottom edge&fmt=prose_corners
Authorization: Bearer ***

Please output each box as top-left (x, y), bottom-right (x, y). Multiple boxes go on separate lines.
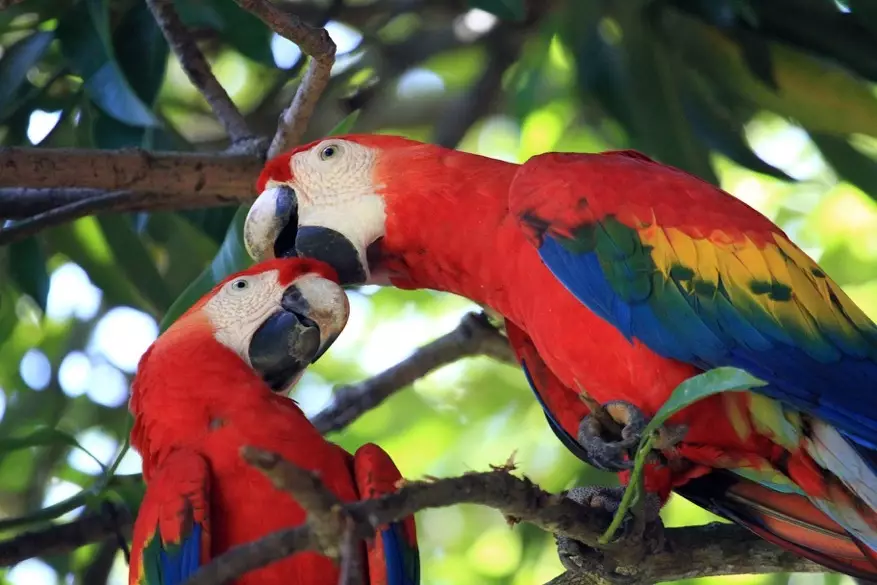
top-left (129, 450), bottom-right (210, 585)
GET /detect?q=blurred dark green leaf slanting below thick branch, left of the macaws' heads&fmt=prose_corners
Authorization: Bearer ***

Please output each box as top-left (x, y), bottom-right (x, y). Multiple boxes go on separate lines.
top-left (97, 215), bottom-right (174, 313)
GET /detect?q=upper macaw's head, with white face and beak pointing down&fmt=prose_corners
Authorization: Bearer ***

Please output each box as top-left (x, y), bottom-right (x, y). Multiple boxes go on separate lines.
top-left (244, 134), bottom-right (444, 285)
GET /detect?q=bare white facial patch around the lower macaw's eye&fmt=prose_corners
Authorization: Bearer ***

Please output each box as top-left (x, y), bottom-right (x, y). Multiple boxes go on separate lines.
top-left (203, 270), bottom-right (285, 365)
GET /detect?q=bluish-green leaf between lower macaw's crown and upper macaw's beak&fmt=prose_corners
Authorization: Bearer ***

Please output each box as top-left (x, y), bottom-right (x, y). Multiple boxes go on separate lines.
top-left (159, 205), bottom-right (253, 331)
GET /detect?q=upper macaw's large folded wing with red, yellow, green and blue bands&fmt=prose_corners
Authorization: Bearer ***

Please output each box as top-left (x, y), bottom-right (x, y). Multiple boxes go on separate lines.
top-left (509, 151), bottom-right (877, 448)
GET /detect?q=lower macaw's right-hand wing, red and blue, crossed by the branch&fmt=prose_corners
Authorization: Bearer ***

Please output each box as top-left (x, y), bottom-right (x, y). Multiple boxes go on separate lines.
top-left (353, 443), bottom-right (420, 585)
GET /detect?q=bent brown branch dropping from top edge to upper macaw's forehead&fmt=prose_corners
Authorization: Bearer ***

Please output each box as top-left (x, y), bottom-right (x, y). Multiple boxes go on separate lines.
top-left (235, 0), bottom-right (335, 158)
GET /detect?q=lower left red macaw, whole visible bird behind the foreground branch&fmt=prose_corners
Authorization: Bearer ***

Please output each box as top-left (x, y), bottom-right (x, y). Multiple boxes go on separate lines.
top-left (129, 258), bottom-right (419, 585)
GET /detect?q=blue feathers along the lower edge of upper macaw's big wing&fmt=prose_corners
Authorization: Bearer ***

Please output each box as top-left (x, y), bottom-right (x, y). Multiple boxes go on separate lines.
top-left (539, 235), bottom-right (877, 449)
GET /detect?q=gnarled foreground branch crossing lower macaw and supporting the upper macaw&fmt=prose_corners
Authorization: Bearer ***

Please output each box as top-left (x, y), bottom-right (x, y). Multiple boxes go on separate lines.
top-left (181, 448), bottom-right (824, 585)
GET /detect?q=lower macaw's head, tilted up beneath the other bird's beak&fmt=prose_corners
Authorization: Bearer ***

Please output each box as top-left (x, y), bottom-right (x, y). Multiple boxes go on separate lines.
top-left (149, 258), bottom-right (349, 392)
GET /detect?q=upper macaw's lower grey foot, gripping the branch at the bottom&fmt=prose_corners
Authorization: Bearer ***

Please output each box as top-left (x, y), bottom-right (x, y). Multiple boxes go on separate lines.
top-left (555, 486), bottom-right (664, 585)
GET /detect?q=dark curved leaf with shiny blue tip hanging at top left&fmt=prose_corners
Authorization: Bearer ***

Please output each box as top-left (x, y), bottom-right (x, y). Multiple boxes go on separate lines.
top-left (58, 0), bottom-right (158, 127)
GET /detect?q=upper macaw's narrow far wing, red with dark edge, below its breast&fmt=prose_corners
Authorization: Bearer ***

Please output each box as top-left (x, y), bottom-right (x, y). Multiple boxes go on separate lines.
top-left (505, 319), bottom-right (599, 467)
